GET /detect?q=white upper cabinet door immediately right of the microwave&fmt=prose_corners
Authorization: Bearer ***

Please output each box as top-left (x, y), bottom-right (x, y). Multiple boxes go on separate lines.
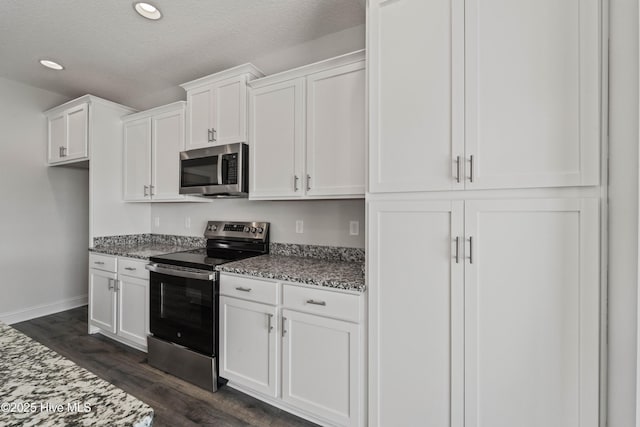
top-left (249, 79), bottom-right (304, 199)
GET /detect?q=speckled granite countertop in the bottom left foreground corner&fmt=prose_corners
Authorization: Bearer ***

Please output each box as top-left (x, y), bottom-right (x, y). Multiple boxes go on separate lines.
top-left (0, 322), bottom-right (153, 427)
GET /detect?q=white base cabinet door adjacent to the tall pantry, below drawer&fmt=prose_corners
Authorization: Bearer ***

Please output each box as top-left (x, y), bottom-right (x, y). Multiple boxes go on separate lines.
top-left (282, 310), bottom-right (362, 426)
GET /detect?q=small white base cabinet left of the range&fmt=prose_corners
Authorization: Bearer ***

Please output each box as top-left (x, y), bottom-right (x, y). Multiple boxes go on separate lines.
top-left (89, 254), bottom-right (149, 351)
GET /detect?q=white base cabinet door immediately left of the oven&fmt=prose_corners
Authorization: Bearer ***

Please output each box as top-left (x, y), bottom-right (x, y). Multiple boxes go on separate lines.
top-left (118, 276), bottom-right (149, 348)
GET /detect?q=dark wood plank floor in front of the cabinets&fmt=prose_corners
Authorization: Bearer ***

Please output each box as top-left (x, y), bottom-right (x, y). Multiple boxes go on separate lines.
top-left (12, 307), bottom-right (315, 427)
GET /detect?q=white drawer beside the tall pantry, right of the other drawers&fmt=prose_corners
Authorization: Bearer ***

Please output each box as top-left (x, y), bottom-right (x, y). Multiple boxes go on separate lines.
top-left (282, 285), bottom-right (361, 322)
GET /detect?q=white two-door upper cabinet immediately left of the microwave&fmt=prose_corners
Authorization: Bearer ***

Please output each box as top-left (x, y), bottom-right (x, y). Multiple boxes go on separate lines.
top-left (123, 101), bottom-right (206, 202)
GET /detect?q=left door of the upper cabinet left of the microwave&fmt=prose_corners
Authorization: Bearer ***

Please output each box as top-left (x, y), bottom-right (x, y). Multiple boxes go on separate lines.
top-left (124, 118), bottom-right (151, 201)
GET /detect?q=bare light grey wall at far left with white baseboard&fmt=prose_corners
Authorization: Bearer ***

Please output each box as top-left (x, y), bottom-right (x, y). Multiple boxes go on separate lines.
top-left (0, 78), bottom-right (89, 322)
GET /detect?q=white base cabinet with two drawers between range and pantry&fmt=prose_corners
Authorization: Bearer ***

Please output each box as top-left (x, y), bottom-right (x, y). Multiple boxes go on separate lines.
top-left (219, 274), bottom-right (366, 426)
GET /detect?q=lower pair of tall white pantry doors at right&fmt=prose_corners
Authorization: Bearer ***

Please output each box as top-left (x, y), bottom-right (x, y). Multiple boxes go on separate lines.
top-left (368, 199), bottom-right (600, 427)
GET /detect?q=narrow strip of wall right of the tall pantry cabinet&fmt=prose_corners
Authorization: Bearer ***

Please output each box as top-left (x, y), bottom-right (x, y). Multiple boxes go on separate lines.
top-left (608, 0), bottom-right (638, 427)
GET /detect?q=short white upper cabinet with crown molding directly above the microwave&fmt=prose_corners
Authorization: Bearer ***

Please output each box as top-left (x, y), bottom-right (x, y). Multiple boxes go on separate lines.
top-left (181, 64), bottom-right (263, 150)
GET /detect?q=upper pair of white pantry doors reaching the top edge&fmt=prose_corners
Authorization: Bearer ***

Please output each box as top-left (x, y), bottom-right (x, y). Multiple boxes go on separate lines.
top-left (368, 0), bottom-right (601, 193)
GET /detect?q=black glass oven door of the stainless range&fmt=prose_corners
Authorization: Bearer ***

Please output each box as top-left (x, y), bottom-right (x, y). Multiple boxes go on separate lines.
top-left (149, 264), bottom-right (218, 356)
